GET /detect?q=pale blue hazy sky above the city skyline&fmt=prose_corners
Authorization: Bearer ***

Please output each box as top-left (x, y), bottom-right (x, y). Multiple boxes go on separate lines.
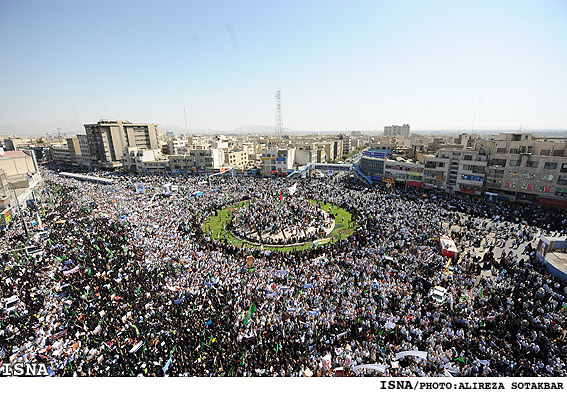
top-left (0, 0), bottom-right (567, 131)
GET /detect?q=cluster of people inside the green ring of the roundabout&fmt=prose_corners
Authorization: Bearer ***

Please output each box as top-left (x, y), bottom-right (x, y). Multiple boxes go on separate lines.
top-left (228, 193), bottom-right (333, 245)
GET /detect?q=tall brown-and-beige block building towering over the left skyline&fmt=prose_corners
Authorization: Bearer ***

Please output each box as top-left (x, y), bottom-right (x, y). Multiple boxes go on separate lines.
top-left (85, 120), bottom-right (158, 168)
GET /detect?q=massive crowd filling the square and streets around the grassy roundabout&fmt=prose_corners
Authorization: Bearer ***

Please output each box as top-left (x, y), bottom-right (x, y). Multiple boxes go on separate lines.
top-left (0, 166), bottom-right (567, 376)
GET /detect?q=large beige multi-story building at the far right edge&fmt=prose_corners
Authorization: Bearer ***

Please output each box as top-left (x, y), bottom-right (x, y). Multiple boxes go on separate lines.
top-left (486, 133), bottom-right (567, 207)
